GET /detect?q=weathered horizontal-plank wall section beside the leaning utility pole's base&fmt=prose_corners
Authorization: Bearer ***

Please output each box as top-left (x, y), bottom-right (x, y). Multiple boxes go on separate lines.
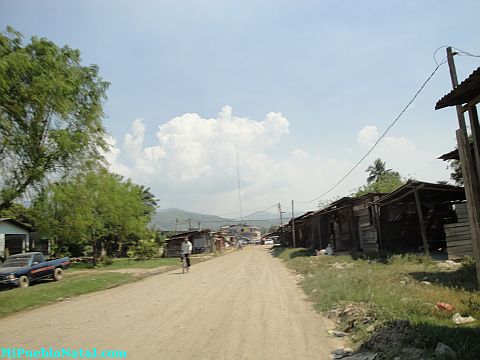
top-left (444, 203), bottom-right (473, 260)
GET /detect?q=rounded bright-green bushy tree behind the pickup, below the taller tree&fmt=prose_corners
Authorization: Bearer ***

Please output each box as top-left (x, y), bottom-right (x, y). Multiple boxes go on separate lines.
top-left (34, 168), bottom-right (158, 262)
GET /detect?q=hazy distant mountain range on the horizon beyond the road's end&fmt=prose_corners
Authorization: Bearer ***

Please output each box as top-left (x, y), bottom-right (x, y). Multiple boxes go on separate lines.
top-left (152, 209), bottom-right (288, 231)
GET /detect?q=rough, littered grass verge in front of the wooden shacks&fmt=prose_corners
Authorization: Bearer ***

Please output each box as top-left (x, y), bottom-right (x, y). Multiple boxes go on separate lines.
top-left (274, 249), bottom-right (480, 359)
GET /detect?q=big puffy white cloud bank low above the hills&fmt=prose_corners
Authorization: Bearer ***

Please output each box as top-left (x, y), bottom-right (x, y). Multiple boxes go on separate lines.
top-left (105, 111), bottom-right (452, 216)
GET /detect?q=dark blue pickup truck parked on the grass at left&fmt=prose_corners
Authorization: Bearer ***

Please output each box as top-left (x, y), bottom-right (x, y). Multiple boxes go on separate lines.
top-left (0, 252), bottom-right (70, 288)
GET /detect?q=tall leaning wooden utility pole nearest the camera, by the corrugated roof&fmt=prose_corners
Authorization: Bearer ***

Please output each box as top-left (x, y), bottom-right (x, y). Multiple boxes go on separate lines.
top-left (447, 47), bottom-right (480, 285)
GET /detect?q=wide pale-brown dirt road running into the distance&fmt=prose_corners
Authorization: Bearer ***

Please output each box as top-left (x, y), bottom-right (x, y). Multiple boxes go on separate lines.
top-left (0, 246), bottom-right (340, 360)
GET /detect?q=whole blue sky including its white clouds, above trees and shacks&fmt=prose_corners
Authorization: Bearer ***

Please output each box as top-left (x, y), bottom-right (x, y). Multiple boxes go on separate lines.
top-left (0, 0), bottom-right (480, 216)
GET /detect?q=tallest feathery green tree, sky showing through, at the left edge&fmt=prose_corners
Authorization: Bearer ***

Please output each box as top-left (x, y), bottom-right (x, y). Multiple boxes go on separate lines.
top-left (0, 27), bottom-right (109, 210)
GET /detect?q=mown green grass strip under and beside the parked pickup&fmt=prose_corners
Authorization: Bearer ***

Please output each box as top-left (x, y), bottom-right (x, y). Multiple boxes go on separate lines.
top-left (0, 272), bottom-right (134, 317)
